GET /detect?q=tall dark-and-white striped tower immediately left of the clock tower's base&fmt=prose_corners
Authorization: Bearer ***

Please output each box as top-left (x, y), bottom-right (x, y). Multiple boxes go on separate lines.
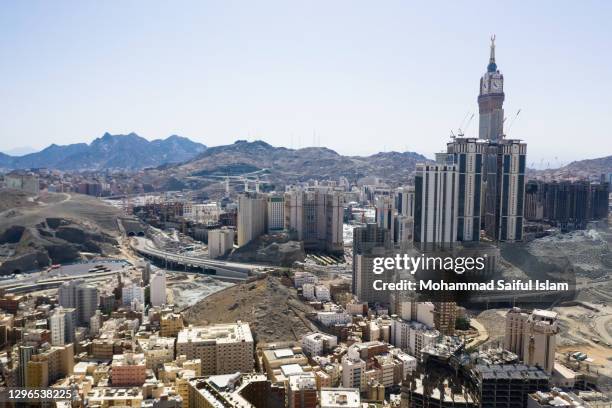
top-left (447, 138), bottom-right (487, 241)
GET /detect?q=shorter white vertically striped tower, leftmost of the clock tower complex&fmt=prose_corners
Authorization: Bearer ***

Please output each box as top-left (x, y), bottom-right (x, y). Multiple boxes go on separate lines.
top-left (414, 164), bottom-right (459, 244)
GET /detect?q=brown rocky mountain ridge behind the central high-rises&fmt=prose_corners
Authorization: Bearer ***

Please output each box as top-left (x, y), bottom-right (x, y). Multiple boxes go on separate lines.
top-left (148, 140), bottom-right (429, 188)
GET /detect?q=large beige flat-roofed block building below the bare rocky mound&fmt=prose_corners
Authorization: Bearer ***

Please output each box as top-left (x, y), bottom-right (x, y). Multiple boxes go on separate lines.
top-left (176, 321), bottom-right (254, 375)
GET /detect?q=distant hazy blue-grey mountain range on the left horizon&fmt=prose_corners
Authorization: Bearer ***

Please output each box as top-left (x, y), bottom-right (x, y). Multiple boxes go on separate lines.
top-left (0, 133), bottom-right (206, 170)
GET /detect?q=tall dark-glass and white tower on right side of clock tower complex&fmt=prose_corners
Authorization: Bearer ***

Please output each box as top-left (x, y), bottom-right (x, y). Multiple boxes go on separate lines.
top-left (484, 139), bottom-right (527, 242)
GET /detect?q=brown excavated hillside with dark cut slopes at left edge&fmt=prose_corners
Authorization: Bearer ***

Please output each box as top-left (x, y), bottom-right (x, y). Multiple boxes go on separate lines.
top-left (0, 189), bottom-right (120, 275)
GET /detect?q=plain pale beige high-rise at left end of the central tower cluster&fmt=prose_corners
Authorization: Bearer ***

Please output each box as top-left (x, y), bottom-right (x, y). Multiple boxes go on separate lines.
top-left (238, 193), bottom-right (267, 247)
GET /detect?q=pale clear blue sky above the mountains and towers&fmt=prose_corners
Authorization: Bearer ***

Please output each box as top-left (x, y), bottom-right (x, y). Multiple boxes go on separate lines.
top-left (0, 0), bottom-right (612, 166)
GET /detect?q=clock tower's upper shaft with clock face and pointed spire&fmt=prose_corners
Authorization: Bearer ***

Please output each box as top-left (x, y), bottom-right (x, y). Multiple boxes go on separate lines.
top-left (478, 36), bottom-right (504, 141)
